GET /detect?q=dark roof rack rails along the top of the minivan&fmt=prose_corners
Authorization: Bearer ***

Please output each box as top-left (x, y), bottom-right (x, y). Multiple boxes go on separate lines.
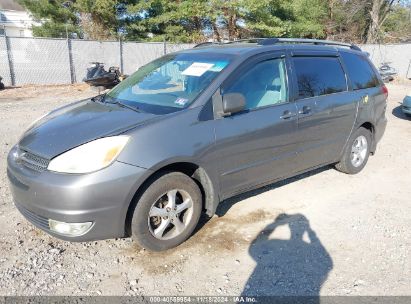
top-left (194, 38), bottom-right (361, 51)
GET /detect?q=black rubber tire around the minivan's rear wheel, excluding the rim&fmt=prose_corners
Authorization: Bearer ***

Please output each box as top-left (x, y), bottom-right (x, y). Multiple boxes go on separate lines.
top-left (335, 127), bottom-right (372, 174)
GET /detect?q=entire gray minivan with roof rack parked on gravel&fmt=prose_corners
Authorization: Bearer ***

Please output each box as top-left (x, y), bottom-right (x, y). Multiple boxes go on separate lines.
top-left (7, 38), bottom-right (388, 251)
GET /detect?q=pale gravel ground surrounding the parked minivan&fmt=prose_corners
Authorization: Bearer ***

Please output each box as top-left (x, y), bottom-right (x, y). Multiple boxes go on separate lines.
top-left (0, 83), bottom-right (411, 295)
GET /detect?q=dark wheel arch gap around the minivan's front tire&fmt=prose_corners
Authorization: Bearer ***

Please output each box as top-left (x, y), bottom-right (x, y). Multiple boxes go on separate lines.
top-left (125, 161), bottom-right (219, 235)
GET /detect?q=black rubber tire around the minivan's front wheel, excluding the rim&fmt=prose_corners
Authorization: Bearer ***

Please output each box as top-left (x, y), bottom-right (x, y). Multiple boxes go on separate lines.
top-left (131, 172), bottom-right (202, 251)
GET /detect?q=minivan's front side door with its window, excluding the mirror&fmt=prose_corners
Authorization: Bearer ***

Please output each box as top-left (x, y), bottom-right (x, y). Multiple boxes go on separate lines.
top-left (215, 53), bottom-right (297, 198)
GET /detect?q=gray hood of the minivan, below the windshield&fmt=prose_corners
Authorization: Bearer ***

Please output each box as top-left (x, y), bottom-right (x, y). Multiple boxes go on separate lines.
top-left (18, 100), bottom-right (156, 159)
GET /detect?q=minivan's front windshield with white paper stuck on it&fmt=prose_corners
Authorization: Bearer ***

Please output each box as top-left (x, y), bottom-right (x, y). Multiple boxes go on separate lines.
top-left (107, 54), bottom-right (230, 114)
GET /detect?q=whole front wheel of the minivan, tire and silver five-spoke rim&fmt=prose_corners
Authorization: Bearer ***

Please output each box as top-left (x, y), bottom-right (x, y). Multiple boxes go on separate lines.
top-left (131, 172), bottom-right (202, 251)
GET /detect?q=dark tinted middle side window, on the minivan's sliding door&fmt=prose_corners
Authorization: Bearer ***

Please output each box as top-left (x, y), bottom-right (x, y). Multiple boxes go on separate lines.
top-left (294, 57), bottom-right (347, 99)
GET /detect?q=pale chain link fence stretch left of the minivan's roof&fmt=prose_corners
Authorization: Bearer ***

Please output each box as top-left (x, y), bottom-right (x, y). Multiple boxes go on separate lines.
top-left (0, 36), bottom-right (194, 86)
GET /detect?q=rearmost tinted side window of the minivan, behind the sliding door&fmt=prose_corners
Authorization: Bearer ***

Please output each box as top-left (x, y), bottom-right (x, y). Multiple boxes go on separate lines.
top-left (341, 52), bottom-right (379, 90)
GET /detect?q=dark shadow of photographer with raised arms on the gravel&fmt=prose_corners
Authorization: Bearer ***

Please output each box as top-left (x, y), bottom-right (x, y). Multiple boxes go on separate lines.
top-left (242, 214), bottom-right (333, 303)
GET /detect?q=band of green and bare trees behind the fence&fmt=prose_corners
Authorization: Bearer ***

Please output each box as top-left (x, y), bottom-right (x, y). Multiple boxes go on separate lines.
top-left (18, 0), bottom-right (411, 42)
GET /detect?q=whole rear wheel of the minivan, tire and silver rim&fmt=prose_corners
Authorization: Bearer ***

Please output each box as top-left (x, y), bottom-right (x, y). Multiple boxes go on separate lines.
top-left (335, 127), bottom-right (372, 174)
